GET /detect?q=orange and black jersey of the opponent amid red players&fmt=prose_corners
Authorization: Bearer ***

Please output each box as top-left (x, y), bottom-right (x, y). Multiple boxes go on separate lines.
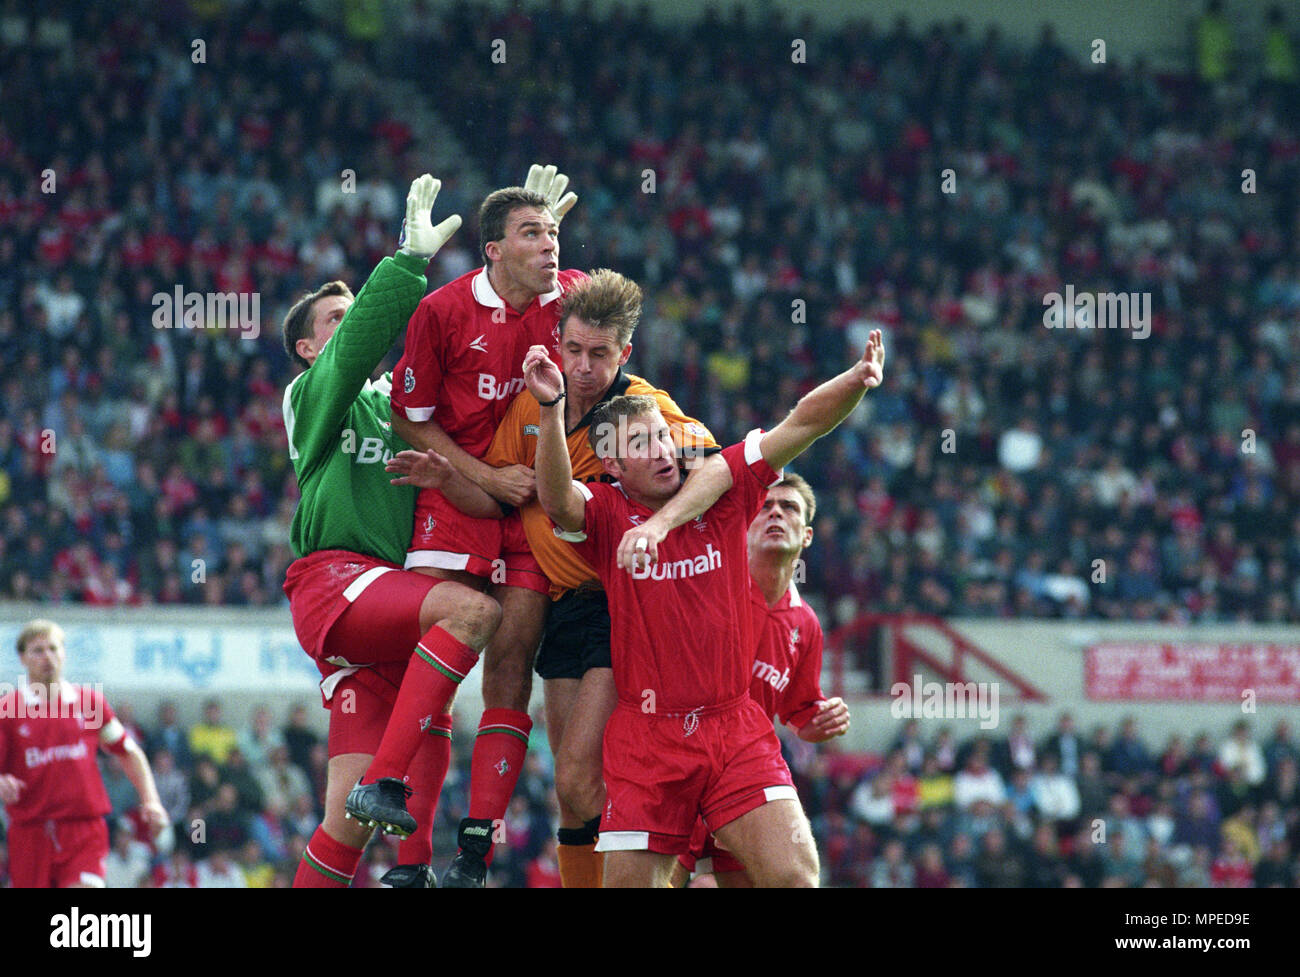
top-left (484, 369), bottom-right (722, 600)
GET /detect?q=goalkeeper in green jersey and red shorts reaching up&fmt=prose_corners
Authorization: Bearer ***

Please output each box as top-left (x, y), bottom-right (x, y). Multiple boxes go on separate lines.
top-left (283, 174), bottom-right (501, 889)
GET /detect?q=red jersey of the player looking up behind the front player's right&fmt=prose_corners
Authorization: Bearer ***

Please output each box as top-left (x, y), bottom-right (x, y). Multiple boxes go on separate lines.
top-left (749, 579), bottom-right (826, 729)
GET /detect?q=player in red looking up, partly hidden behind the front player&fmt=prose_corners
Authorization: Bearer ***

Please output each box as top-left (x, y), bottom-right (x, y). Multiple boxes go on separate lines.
top-left (673, 472), bottom-right (849, 889)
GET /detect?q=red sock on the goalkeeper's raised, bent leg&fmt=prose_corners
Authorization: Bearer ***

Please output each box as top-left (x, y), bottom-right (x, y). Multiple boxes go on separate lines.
top-left (361, 628), bottom-right (478, 783)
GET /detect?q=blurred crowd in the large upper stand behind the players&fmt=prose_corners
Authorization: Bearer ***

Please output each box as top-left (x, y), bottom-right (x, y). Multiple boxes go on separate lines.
top-left (0, 0), bottom-right (1300, 628)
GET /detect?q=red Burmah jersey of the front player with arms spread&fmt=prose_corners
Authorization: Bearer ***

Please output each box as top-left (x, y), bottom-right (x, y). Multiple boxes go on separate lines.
top-left (575, 430), bottom-right (780, 712)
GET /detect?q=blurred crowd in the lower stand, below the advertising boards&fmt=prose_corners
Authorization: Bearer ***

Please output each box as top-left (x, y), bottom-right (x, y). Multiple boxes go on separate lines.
top-left (0, 700), bottom-right (1300, 889)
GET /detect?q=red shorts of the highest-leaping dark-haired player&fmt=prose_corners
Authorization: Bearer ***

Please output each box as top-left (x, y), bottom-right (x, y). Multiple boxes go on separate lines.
top-left (406, 490), bottom-right (550, 594)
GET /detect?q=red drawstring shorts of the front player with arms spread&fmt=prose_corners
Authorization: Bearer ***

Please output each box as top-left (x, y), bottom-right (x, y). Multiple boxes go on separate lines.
top-left (595, 695), bottom-right (797, 855)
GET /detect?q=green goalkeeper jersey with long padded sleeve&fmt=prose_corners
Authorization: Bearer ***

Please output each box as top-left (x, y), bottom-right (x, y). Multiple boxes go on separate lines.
top-left (285, 252), bottom-right (426, 565)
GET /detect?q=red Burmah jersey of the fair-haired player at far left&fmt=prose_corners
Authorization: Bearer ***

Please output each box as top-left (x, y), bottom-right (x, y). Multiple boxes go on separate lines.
top-left (0, 682), bottom-right (126, 824)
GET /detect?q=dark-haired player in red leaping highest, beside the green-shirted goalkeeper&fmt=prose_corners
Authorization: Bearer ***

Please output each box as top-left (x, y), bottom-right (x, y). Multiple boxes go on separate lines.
top-left (379, 166), bottom-right (585, 889)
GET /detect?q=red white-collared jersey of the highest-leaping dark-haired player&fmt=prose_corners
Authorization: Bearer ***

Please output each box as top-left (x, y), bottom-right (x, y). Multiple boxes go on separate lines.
top-left (391, 261), bottom-right (586, 457)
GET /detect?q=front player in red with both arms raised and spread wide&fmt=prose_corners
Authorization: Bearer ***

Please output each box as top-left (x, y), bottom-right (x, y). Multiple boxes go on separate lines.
top-left (524, 330), bottom-right (884, 887)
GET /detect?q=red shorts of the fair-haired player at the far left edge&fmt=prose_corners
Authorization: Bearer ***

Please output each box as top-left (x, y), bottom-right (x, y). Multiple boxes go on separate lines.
top-left (8, 817), bottom-right (108, 889)
